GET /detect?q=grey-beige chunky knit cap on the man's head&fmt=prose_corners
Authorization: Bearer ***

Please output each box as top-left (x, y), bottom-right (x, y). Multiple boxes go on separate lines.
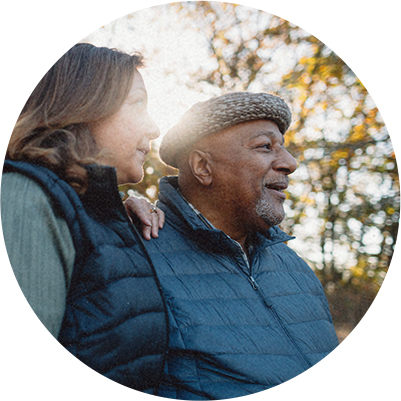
top-left (159, 92), bottom-right (291, 168)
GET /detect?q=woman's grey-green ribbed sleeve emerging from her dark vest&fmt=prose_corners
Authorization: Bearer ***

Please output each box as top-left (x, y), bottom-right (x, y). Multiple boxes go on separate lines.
top-left (1, 173), bottom-right (75, 338)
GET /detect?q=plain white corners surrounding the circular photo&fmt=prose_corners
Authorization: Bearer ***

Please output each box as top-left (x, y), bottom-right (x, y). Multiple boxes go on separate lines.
top-left (0, 0), bottom-right (401, 401)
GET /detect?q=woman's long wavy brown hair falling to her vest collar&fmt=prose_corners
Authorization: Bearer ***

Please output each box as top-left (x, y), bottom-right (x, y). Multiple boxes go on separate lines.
top-left (6, 43), bottom-right (143, 194)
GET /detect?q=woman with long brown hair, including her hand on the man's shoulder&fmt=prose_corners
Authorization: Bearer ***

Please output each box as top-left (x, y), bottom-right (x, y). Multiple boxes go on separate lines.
top-left (1, 44), bottom-right (167, 393)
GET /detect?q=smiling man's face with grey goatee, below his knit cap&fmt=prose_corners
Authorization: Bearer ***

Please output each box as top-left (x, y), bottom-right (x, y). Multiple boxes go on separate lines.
top-left (200, 120), bottom-right (297, 231)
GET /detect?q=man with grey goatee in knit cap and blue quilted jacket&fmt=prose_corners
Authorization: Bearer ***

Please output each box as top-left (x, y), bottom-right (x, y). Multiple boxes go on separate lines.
top-left (141, 92), bottom-right (338, 399)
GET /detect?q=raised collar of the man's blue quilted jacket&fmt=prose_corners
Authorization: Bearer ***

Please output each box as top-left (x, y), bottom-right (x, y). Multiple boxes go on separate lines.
top-left (158, 176), bottom-right (295, 248)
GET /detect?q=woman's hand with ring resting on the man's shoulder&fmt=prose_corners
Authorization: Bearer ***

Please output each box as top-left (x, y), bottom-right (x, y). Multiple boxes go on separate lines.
top-left (124, 195), bottom-right (165, 241)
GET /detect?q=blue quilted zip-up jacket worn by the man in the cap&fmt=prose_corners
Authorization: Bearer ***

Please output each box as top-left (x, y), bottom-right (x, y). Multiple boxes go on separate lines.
top-left (141, 177), bottom-right (338, 400)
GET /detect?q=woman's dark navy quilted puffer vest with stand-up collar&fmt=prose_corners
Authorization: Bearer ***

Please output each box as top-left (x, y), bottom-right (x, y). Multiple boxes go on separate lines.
top-left (4, 161), bottom-right (168, 393)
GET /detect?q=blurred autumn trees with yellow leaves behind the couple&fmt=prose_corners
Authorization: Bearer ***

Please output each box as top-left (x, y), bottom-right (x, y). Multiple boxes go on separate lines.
top-left (106, 2), bottom-right (400, 340)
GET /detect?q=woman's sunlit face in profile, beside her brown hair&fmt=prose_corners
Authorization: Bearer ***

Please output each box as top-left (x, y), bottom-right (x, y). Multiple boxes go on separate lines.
top-left (91, 71), bottom-right (160, 185)
